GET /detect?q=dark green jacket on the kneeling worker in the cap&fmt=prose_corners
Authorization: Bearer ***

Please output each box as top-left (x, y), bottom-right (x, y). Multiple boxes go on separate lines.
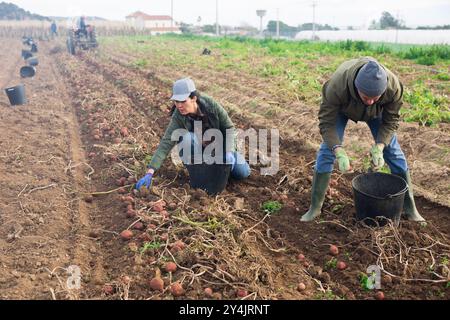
top-left (148, 95), bottom-right (236, 170)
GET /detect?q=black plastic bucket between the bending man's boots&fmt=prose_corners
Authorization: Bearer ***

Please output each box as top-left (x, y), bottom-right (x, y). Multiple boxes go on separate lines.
top-left (352, 172), bottom-right (408, 226)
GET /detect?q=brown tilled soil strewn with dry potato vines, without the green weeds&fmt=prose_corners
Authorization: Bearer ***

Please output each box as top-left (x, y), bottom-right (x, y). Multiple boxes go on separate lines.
top-left (0, 40), bottom-right (450, 299)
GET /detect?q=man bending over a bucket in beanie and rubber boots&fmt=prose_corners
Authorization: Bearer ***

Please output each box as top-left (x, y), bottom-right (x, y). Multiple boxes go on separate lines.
top-left (301, 57), bottom-right (424, 221)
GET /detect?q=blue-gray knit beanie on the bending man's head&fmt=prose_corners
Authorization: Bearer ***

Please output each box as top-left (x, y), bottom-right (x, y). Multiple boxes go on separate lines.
top-left (355, 60), bottom-right (387, 97)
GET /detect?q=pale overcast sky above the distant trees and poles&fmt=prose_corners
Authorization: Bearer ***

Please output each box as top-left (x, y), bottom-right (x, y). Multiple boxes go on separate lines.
top-left (6, 0), bottom-right (450, 27)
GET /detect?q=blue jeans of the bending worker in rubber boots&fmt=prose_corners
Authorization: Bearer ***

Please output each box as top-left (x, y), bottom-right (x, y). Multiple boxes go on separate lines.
top-left (316, 114), bottom-right (408, 174)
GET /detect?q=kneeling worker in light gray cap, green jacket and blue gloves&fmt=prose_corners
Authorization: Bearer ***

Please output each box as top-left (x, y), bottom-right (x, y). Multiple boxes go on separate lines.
top-left (136, 78), bottom-right (250, 190)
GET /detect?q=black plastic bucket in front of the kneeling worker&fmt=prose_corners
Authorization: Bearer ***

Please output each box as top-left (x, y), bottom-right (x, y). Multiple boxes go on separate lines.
top-left (186, 163), bottom-right (231, 195)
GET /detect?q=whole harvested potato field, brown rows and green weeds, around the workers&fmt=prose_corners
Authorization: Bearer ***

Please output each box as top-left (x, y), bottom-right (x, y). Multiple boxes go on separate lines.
top-left (0, 36), bottom-right (450, 300)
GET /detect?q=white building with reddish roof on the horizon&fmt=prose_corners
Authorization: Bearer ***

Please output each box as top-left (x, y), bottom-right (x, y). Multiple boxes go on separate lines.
top-left (126, 11), bottom-right (181, 35)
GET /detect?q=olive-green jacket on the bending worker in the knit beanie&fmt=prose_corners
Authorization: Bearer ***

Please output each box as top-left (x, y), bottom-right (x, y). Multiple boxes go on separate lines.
top-left (319, 57), bottom-right (403, 149)
